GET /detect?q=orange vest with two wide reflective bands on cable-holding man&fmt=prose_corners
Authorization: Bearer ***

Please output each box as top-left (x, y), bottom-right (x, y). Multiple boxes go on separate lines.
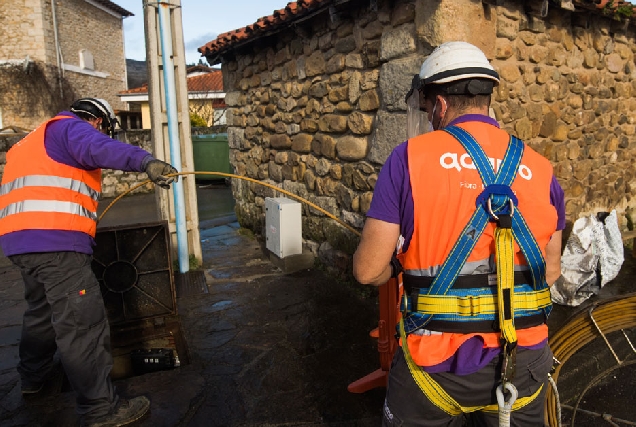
top-left (0, 116), bottom-right (102, 237)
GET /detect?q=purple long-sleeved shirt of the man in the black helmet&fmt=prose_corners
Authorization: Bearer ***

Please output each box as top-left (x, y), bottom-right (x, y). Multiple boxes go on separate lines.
top-left (0, 111), bottom-right (152, 256)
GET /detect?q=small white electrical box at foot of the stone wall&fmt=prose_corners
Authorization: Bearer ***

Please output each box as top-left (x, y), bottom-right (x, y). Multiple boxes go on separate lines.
top-left (265, 197), bottom-right (303, 258)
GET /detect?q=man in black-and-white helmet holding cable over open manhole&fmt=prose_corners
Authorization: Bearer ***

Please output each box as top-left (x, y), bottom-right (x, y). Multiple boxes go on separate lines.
top-left (0, 98), bottom-right (177, 427)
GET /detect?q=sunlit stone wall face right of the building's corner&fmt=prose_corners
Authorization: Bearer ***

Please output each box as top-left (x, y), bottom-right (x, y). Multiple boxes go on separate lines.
top-left (486, 3), bottom-right (636, 226)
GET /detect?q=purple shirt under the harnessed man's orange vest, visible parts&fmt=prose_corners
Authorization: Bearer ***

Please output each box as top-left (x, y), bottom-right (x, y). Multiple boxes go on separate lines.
top-left (367, 114), bottom-right (565, 375)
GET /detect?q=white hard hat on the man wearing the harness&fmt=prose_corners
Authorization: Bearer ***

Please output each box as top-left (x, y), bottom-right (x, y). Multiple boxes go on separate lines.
top-left (420, 42), bottom-right (499, 86)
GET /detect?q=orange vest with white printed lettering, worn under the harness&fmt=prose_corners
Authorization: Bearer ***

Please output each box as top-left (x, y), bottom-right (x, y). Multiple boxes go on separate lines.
top-left (399, 122), bottom-right (557, 366)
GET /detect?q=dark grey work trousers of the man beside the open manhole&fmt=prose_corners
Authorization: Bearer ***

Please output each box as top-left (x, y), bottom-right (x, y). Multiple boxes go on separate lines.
top-left (9, 252), bottom-right (117, 417)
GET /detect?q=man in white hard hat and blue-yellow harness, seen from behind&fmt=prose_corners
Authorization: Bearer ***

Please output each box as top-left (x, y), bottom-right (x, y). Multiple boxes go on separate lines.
top-left (353, 42), bottom-right (565, 426)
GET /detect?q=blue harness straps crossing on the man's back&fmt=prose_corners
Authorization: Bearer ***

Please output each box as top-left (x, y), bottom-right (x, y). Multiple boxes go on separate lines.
top-left (403, 126), bottom-right (551, 334)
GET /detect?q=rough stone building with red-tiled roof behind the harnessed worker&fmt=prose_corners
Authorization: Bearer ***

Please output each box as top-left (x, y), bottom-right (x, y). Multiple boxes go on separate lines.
top-left (199, 0), bottom-right (636, 270)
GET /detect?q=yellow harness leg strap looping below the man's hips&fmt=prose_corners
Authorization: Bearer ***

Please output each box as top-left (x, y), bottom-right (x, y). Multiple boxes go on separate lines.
top-left (399, 319), bottom-right (543, 416)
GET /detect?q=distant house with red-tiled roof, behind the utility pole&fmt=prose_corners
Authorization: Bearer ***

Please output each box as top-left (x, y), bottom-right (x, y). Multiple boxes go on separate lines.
top-left (119, 65), bottom-right (227, 129)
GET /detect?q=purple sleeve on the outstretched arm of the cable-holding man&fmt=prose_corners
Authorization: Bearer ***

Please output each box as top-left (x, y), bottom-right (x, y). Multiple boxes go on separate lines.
top-left (44, 113), bottom-right (151, 172)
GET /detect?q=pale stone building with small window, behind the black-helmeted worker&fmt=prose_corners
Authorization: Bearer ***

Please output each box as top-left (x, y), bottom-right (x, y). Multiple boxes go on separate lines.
top-left (0, 0), bottom-right (132, 129)
